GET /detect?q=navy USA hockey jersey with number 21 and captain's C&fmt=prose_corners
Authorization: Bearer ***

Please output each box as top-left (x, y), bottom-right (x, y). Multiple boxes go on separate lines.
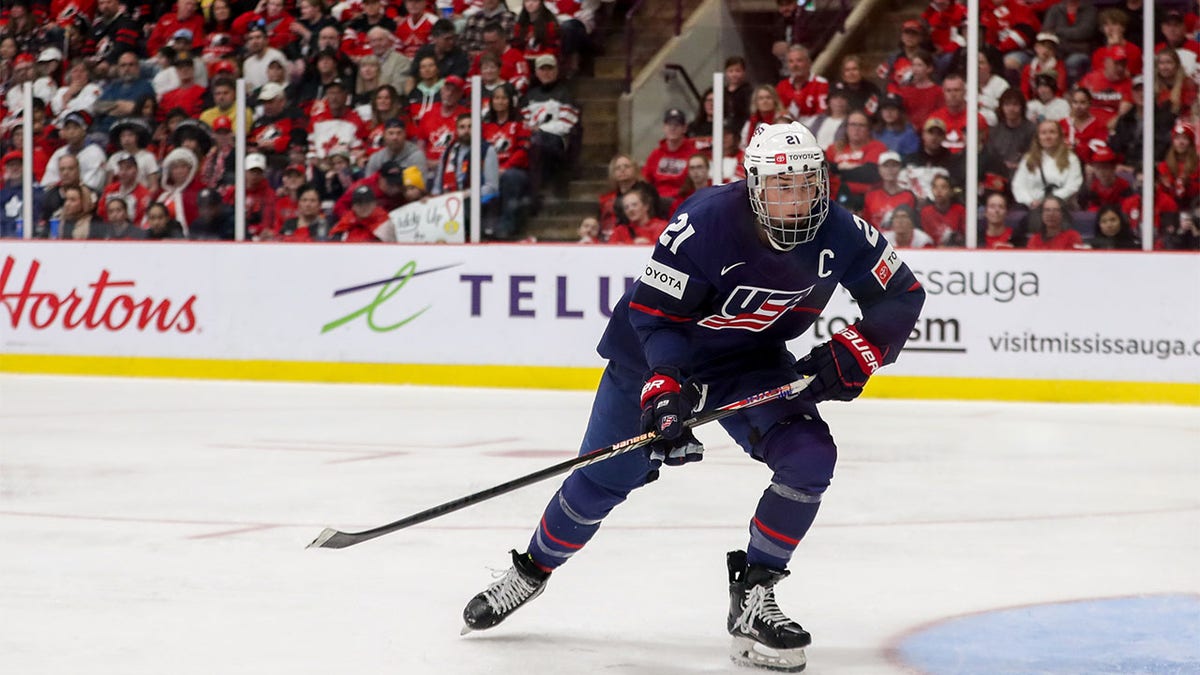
top-left (599, 181), bottom-right (925, 378)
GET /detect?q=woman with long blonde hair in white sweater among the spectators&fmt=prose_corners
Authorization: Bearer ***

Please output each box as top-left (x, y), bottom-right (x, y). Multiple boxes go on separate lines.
top-left (1012, 120), bottom-right (1084, 211)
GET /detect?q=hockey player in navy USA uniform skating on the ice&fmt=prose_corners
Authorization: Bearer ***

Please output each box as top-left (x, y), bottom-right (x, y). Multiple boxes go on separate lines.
top-left (463, 123), bottom-right (925, 670)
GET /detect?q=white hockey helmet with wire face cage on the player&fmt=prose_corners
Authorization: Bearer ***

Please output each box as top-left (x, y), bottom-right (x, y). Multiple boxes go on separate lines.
top-left (745, 121), bottom-right (829, 251)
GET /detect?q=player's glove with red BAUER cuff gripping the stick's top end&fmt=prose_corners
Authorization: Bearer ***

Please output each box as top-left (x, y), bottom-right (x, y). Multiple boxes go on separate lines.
top-left (796, 325), bottom-right (883, 401)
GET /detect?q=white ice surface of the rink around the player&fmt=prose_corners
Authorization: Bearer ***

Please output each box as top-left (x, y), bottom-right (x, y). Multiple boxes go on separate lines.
top-left (0, 376), bottom-right (1200, 675)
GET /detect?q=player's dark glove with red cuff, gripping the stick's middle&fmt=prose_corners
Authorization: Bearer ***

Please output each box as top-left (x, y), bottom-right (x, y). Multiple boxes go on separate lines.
top-left (642, 369), bottom-right (704, 468)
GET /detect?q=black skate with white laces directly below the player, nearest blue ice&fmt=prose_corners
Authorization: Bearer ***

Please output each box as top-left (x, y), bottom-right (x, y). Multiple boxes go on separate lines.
top-left (727, 551), bottom-right (812, 673)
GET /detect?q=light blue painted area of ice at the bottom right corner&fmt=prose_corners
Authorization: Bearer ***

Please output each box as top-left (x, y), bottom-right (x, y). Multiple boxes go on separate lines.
top-left (893, 595), bottom-right (1200, 675)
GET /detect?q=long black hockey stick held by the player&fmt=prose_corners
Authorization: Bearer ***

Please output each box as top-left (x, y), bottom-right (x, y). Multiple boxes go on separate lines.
top-left (306, 377), bottom-right (812, 549)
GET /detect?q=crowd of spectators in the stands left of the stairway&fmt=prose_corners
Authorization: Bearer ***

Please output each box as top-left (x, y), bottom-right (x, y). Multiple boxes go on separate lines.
top-left (0, 0), bottom-right (600, 241)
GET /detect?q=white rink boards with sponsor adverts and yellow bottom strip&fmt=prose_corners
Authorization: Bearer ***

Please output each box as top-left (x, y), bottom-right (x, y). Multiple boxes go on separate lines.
top-left (0, 241), bottom-right (1200, 405)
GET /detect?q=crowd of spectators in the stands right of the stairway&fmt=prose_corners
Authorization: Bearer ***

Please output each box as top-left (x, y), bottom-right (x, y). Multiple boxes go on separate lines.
top-left (581, 0), bottom-right (1200, 250)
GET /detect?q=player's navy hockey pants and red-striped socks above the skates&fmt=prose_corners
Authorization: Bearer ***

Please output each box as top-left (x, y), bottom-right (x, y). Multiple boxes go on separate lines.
top-left (529, 364), bottom-right (838, 569)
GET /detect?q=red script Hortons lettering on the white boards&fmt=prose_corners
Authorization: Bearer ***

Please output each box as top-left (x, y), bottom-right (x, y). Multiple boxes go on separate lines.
top-left (0, 256), bottom-right (196, 333)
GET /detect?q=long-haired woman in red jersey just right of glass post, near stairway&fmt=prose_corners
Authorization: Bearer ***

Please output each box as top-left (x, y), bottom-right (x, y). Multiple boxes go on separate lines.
top-left (482, 84), bottom-right (529, 239)
